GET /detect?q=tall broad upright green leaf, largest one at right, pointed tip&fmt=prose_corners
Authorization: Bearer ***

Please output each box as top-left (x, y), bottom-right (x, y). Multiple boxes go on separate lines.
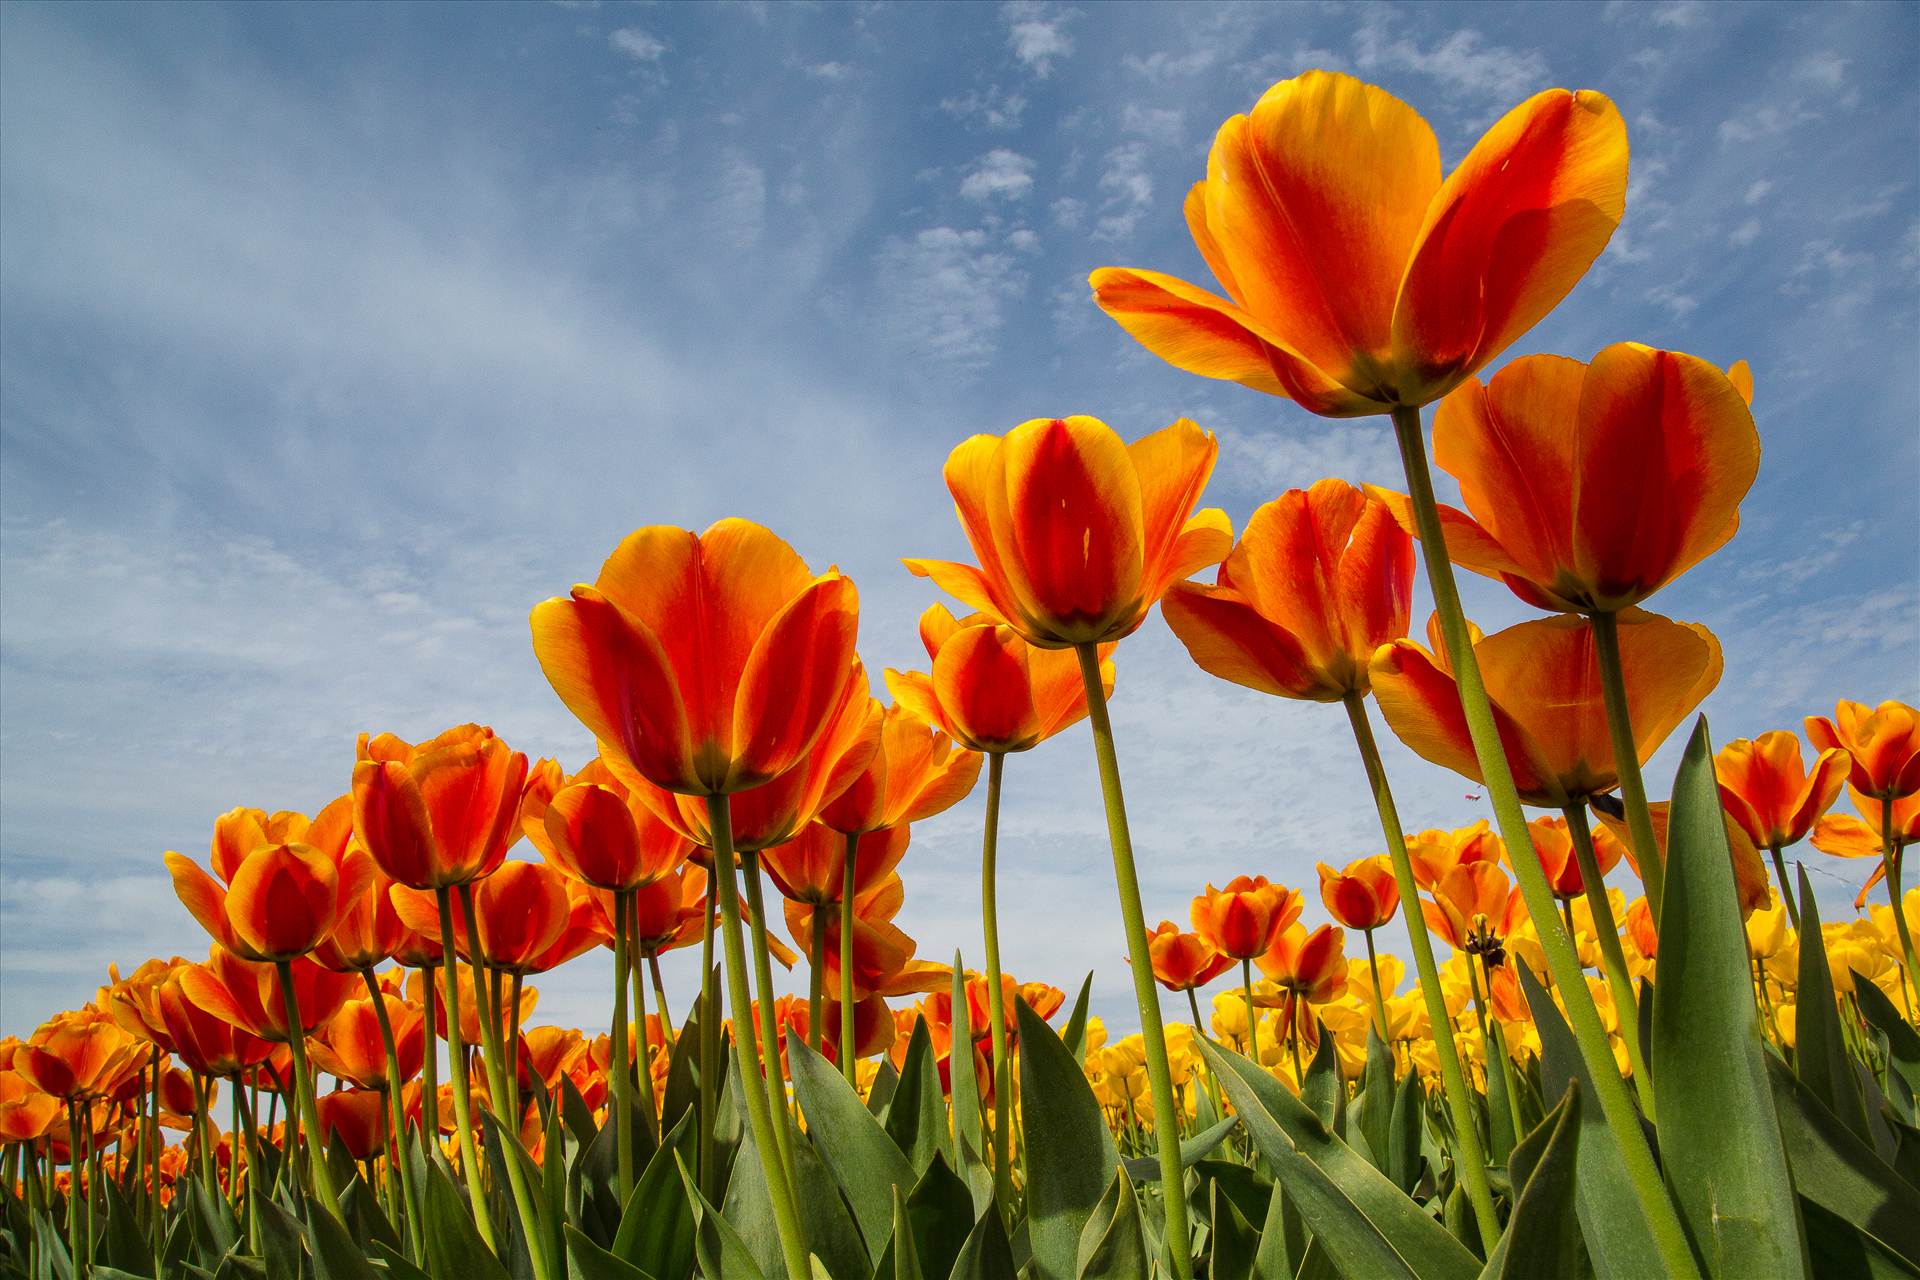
top-left (1653, 716), bottom-right (1824, 1278)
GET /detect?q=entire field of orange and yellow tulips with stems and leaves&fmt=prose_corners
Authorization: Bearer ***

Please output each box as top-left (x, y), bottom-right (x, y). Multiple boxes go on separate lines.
top-left (0, 73), bottom-right (1920, 1280)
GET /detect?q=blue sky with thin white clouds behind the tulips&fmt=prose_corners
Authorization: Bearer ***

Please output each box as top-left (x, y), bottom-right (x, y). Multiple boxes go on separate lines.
top-left (0, 2), bottom-right (1920, 1034)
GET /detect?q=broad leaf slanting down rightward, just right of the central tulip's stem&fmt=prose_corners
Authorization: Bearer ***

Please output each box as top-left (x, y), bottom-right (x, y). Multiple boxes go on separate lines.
top-left (1200, 1040), bottom-right (1480, 1280)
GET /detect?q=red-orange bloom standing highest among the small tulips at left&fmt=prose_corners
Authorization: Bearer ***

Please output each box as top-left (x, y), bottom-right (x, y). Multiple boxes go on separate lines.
top-left (353, 723), bottom-right (526, 889)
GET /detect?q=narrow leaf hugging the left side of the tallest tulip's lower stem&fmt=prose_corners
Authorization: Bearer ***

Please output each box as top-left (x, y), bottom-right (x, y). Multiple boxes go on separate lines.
top-left (1513, 965), bottom-right (1665, 1280)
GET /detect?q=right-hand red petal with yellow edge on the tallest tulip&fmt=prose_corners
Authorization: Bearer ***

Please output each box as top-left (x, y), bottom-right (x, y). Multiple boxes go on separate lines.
top-left (1394, 88), bottom-right (1626, 405)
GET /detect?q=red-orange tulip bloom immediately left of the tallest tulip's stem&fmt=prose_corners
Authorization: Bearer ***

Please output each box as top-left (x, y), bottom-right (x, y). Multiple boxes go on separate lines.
top-left (1162, 480), bottom-right (1413, 702)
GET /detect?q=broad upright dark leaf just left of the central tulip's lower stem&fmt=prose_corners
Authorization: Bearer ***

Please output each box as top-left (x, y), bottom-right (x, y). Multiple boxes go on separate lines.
top-left (1014, 1000), bottom-right (1119, 1280)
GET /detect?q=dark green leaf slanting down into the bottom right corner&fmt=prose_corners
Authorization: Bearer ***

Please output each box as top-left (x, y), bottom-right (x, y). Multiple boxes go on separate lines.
top-left (1766, 1059), bottom-right (1920, 1267)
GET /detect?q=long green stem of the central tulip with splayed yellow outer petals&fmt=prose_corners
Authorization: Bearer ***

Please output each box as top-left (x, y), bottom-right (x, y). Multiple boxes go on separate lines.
top-left (1073, 643), bottom-right (1192, 1280)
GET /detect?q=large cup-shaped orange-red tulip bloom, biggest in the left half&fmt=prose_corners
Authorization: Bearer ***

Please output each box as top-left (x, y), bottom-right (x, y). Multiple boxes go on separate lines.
top-left (532, 520), bottom-right (858, 796)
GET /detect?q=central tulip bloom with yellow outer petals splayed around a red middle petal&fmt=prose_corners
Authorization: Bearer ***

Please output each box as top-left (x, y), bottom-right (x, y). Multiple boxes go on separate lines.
top-left (906, 416), bottom-right (1233, 649)
